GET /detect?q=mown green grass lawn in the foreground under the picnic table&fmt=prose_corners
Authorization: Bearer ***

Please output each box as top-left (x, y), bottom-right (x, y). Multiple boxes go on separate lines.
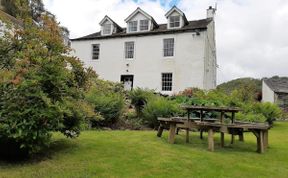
top-left (0, 122), bottom-right (288, 178)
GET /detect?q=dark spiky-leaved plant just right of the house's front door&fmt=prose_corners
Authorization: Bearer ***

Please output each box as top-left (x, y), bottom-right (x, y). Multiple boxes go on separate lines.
top-left (128, 88), bottom-right (154, 117)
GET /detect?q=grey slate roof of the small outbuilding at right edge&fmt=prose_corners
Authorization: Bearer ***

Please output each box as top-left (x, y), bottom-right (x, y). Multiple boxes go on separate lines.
top-left (264, 77), bottom-right (288, 93)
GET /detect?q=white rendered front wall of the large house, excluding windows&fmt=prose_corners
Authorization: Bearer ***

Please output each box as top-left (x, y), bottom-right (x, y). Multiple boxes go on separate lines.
top-left (72, 32), bottom-right (206, 94)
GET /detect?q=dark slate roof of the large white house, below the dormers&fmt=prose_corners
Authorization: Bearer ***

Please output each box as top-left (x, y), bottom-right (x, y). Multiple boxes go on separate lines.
top-left (71, 18), bottom-right (213, 41)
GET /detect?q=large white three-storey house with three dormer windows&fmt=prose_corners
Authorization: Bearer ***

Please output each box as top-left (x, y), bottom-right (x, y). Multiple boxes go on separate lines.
top-left (71, 6), bottom-right (217, 95)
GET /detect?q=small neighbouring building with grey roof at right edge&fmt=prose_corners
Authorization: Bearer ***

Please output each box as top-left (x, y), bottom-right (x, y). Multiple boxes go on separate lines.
top-left (262, 77), bottom-right (288, 111)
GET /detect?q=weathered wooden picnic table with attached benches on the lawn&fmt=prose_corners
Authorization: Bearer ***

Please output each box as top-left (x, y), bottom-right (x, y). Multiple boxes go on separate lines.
top-left (157, 106), bottom-right (270, 153)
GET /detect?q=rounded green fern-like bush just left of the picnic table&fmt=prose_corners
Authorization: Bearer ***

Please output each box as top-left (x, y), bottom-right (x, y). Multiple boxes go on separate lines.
top-left (143, 96), bottom-right (183, 128)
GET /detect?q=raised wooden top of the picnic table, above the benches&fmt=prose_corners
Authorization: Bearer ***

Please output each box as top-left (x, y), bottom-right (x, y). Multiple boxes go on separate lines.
top-left (181, 105), bottom-right (241, 112)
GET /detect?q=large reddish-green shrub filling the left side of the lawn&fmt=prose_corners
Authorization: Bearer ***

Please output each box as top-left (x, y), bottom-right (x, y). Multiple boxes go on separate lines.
top-left (0, 1), bottom-right (96, 153)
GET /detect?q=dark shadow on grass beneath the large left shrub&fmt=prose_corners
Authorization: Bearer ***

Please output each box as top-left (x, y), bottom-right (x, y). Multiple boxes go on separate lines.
top-left (0, 138), bottom-right (77, 167)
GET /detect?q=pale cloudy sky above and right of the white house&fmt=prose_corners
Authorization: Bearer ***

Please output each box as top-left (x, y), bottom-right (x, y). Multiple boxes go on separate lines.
top-left (44, 0), bottom-right (288, 84)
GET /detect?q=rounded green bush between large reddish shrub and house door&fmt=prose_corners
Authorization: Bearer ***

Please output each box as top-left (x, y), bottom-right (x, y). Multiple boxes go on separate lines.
top-left (86, 80), bottom-right (125, 127)
